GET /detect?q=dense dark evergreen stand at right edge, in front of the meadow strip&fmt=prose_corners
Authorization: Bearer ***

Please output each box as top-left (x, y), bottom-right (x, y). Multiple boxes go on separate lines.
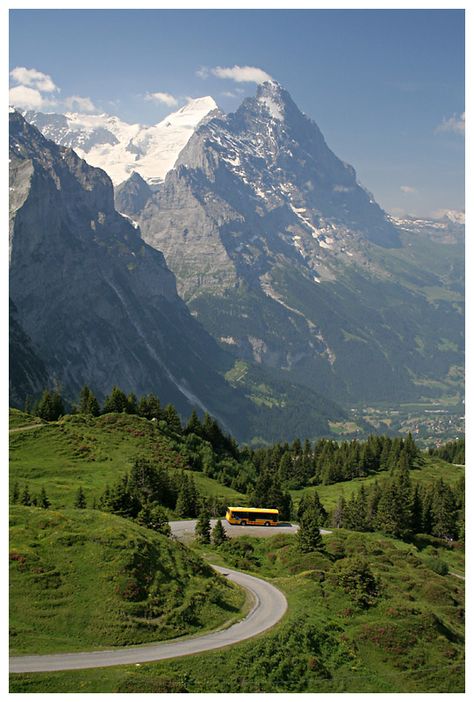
top-left (327, 469), bottom-right (464, 541)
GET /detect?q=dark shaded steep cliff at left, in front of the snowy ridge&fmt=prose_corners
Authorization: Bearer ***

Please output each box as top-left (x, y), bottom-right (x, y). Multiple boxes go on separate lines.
top-left (10, 112), bottom-right (344, 440)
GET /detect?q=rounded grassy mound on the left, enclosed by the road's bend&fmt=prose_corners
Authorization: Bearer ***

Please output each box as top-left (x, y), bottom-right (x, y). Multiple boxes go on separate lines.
top-left (10, 506), bottom-right (245, 654)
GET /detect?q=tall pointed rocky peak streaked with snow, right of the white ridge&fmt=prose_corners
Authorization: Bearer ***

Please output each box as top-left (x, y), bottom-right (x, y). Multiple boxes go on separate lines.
top-left (116, 82), bottom-right (463, 402)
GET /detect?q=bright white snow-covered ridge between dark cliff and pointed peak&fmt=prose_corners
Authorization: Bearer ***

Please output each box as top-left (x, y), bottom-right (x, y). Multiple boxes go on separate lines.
top-left (22, 97), bottom-right (217, 190)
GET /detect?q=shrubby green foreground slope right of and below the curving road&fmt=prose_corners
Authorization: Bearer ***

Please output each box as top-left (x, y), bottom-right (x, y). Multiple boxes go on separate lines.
top-left (11, 530), bottom-right (464, 693)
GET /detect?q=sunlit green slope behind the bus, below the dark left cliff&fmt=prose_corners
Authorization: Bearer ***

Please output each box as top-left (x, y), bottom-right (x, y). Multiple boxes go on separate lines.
top-left (10, 410), bottom-right (243, 508)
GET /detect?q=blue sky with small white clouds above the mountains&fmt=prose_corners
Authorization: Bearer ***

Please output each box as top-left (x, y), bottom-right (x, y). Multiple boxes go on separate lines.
top-left (10, 10), bottom-right (464, 215)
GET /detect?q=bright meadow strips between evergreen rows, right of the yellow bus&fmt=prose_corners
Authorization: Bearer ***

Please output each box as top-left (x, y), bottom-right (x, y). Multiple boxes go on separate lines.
top-left (290, 456), bottom-right (464, 510)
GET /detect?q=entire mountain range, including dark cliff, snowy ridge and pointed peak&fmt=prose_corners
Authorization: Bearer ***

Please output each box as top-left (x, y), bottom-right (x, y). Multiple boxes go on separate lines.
top-left (10, 82), bottom-right (464, 438)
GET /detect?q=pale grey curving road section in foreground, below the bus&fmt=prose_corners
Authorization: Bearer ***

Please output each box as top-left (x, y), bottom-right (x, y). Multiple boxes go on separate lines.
top-left (10, 566), bottom-right (288, 673)
